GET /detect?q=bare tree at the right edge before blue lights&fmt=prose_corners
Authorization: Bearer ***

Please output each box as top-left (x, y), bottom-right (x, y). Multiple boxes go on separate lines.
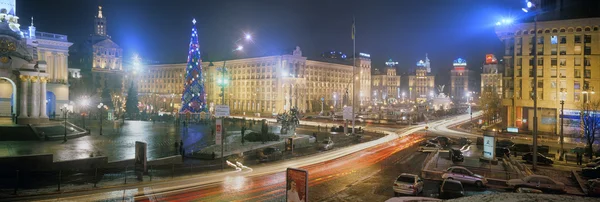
top-left (580, 99), bottom-right (600, 159)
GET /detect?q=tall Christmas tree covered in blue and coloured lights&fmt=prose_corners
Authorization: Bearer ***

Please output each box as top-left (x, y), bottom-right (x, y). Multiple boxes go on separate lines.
top-left (179, 19), bottom-right (206, 114)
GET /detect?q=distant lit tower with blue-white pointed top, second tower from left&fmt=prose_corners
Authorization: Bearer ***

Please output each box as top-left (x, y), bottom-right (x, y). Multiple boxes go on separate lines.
top-left (408, 57), bottom-right (435, 103)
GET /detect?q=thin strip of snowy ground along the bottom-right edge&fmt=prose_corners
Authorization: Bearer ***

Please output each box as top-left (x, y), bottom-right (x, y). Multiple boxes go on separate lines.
top-left (447, 193), bottom-right (600, 202)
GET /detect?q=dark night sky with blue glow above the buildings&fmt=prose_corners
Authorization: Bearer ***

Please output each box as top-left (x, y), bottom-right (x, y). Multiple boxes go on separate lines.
top-left (17, 0), bottom-right (524, 88)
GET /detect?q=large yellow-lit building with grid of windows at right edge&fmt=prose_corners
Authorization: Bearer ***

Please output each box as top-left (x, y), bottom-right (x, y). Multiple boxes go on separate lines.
top-left (496, 18), bottom-right (600, 134)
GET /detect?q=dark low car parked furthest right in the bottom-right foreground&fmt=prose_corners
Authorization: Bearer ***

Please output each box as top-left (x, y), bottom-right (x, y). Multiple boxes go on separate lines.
top-left (506, 175), bottom-right (566, 193)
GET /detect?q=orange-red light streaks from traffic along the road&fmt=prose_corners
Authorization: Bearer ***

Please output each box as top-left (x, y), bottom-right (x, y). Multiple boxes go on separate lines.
top-left (135, 133), bottom-right (425, 201)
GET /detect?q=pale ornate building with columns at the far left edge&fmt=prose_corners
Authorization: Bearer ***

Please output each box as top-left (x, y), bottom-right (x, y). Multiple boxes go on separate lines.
top-left (0, 0), bottom-right (72, 124)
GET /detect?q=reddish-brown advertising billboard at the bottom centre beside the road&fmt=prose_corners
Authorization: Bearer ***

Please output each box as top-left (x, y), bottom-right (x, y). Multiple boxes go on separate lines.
top-left (285, 168), bottom-right (308, 202)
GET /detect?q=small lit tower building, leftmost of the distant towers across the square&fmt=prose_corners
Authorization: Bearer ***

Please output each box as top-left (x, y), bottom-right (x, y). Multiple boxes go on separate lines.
top-left (371, 59), bottom-right (401, 103)
